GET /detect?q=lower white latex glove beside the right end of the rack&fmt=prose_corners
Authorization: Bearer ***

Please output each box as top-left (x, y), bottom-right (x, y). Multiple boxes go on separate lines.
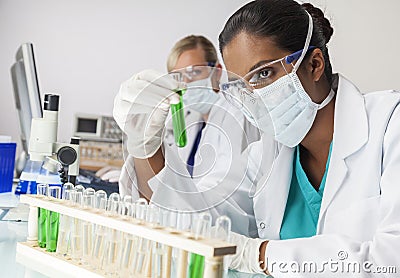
top-left (229, 232), bottom-right (265, 273)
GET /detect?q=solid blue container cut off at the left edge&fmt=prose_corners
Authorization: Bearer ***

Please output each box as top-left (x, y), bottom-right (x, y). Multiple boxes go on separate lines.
top-left (0, 143), bottom-right (17, 193)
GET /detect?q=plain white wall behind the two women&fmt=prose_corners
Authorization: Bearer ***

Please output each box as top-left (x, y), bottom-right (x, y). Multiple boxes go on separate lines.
top-left (0, 0), bottom-right (400, 155)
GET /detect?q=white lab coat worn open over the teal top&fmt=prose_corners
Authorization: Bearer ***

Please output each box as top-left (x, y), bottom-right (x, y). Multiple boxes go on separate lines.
top-left (244, 75), bottom-right (400, 277)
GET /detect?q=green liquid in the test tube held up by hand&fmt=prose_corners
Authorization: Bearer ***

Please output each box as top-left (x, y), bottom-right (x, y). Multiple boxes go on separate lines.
top-left (171, 89), bottom-right (187, 147)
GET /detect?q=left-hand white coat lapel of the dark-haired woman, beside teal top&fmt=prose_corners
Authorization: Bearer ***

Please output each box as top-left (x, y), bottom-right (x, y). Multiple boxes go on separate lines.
top-left (254, 145), bottom-right (294, 239)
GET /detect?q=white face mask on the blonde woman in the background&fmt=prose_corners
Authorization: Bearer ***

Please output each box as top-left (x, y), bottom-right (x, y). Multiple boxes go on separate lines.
top-left (183, 77), bottom-right (219, 114)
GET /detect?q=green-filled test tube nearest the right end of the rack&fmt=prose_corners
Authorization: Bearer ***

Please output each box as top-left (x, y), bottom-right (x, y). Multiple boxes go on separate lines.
top-left (189, 212), bottom-right (211, 278)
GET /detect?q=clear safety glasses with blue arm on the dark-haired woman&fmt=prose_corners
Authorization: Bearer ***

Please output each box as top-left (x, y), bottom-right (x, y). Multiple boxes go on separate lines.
top-left (220, 46), bottom-right (315, 108)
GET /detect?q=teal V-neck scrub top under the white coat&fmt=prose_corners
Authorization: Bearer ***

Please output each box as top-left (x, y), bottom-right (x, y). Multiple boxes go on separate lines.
top-left (280, 143), bottom-right (332, 239)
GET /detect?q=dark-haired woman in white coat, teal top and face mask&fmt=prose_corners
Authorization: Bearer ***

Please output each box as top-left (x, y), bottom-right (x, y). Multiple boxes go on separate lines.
top-left (219, 0), bottom-right (400, 277)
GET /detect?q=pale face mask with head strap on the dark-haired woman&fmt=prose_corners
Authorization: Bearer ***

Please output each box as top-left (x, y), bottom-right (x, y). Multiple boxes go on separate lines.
top-left (242, 12), bottom-right (335, 147)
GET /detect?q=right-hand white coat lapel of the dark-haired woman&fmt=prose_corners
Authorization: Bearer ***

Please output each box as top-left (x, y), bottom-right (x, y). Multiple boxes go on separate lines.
top-left (317, 75), bottom-right (368, 230)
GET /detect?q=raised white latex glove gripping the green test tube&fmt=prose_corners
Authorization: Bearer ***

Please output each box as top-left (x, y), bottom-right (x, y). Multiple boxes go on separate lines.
top-left (113, 70), bottom-right (179, 158)
